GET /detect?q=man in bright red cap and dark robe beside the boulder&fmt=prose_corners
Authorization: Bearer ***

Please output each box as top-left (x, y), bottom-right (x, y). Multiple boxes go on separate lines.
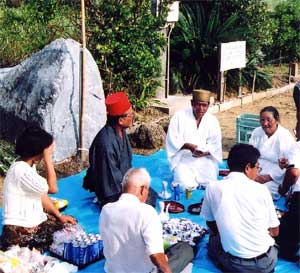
top-left (83, 92), bottom-right (133, 206)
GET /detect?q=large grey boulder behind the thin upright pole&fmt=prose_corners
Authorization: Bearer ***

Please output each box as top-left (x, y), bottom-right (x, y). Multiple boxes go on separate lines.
top-left (0, 39), bottom-right (106, 162)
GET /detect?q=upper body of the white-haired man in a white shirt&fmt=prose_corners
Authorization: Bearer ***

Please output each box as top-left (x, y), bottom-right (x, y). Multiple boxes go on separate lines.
top-left (100, 168), bottom-right (171, 273)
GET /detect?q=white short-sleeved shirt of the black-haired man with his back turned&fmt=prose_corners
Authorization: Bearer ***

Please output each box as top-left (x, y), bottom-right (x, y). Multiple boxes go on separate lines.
top-left (201, 172), bottom-right (279, 258)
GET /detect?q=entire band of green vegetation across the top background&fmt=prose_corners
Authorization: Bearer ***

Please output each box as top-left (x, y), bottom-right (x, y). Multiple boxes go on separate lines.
top-left (0, 0), bottom-right (300, 104)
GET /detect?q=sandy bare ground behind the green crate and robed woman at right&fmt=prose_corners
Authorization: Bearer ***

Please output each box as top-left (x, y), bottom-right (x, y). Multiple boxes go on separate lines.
top-left (215, 91), bottom-right (296, 158)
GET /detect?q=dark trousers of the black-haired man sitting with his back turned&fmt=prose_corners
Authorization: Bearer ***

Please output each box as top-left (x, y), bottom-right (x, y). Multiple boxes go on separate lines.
top-left (208, 236), bottom-right (278, 273)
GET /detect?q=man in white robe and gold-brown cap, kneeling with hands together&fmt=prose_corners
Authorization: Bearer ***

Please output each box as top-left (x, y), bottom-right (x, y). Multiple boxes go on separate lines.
top-left (166, 89), bottom-right (222, 188)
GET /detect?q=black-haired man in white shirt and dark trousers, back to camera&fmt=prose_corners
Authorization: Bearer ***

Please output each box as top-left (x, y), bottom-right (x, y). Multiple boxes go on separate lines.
top-left (201, 144), bottom-right (279, 273)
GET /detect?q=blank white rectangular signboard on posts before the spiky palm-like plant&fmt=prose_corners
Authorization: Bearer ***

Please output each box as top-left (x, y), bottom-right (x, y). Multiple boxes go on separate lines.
top-left (220, 41), bottom-right (246, 71)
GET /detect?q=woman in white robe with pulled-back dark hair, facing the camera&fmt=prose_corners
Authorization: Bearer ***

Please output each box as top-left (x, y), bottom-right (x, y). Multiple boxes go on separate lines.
top-left (249, 106), bottom-right (296, 199)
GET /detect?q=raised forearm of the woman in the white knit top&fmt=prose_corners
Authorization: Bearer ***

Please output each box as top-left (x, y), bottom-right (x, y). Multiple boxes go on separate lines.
top-left (43, 143), bottom-right (58, 193)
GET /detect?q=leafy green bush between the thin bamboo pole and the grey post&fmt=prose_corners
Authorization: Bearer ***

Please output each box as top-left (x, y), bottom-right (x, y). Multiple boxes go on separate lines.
top-left (87, 0), bottom-right (166, 108)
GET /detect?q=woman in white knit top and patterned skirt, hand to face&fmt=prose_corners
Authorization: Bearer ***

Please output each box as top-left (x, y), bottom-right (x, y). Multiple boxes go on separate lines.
top-left (1, 127), bottom-right (76, 250)
